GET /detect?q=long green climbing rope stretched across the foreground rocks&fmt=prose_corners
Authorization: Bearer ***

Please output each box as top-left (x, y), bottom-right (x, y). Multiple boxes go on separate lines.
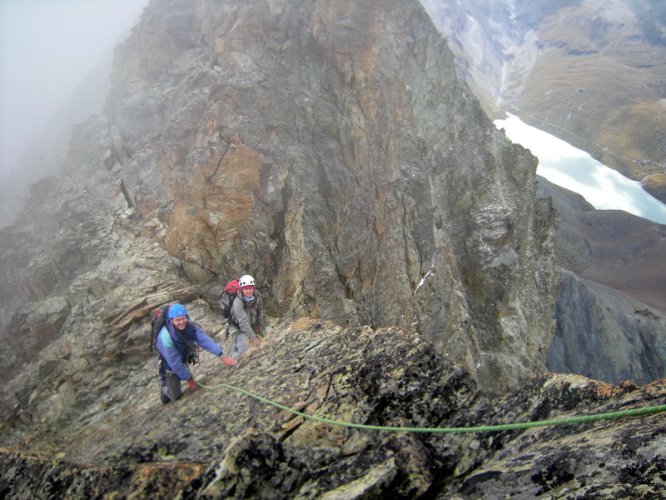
top-left (199, 384), bottom-right (666, 433)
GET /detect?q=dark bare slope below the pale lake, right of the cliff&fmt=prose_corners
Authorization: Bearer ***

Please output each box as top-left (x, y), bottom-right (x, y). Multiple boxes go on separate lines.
top-left (538, 179), bottom-right (666, 383)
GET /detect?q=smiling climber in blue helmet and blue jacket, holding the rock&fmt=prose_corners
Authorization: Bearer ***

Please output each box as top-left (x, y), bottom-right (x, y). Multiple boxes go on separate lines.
top-left (155, 304), bottom-right (236, 404)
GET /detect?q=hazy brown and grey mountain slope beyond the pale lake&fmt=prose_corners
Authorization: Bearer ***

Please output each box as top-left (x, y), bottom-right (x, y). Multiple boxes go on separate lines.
top-left (422, 0), bottom-right (666, 201)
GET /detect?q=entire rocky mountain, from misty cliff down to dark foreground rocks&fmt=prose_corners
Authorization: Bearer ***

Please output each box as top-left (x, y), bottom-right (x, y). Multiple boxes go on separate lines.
top-left (0, 0), bottom-right (664, 498)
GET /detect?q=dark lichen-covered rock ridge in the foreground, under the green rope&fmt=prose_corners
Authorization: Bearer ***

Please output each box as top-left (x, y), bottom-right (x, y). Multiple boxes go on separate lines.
top-left (0, 318), bottom-right (666, 498)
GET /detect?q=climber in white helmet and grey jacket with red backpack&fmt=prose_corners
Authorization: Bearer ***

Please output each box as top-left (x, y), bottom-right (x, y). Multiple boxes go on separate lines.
top-left (227, 274), bottom-right (264, 359)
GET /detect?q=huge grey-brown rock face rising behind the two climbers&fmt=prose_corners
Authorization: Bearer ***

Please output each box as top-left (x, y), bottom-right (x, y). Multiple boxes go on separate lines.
top-left (0, 5), bottom-right (554, 486)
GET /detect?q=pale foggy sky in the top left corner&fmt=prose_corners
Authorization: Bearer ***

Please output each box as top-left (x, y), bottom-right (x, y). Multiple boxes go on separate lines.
top-left (0, 0), bottom-right (148, 177)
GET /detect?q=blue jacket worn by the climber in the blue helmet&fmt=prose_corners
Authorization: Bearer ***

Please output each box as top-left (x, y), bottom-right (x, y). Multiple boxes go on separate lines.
top-left (155, 320), bottom-right (222, 380)
